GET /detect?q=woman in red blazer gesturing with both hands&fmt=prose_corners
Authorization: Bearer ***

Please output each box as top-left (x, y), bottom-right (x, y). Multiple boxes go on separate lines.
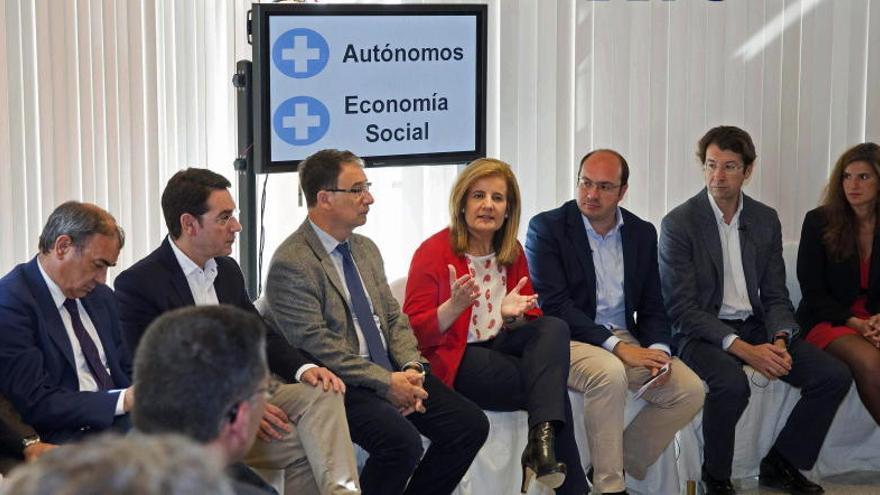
top-left (403, 158), bottom-right (587, 493)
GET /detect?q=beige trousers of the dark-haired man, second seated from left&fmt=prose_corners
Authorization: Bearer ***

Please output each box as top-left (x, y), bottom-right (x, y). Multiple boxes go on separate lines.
top-left (244, 383), bottom-right (361, 495)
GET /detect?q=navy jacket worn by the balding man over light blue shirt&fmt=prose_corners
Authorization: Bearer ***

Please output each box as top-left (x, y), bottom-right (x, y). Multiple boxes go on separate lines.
top-left (526, 200), bottom-right (671, 347)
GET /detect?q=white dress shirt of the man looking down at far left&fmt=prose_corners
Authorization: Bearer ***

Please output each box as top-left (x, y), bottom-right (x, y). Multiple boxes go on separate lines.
top-left (37, 259), bottom-right (125, 416)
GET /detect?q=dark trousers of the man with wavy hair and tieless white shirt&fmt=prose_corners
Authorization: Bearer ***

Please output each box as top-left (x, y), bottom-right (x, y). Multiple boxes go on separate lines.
top-left (680, 318), bottom-right (852, 479)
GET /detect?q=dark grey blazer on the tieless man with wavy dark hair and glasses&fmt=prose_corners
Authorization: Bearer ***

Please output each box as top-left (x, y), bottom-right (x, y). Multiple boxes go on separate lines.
top-left (659, 188), bottom-right (798, 350)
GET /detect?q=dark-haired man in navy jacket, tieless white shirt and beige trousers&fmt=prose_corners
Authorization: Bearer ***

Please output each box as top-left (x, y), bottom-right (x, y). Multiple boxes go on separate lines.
top-left (115, 168), bottom-right (360, 494)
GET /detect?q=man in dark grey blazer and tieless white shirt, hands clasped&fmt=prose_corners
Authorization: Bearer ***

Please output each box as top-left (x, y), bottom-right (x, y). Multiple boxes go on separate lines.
top-left (659, 126), bottom-right (851, 494)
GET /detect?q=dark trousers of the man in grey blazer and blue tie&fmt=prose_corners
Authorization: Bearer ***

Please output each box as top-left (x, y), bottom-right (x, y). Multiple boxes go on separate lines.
top-left (345, 375), bottom-right (489, 495)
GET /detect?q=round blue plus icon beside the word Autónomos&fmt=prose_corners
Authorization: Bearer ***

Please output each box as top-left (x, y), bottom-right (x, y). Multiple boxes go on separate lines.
top-left (272, 28), bottom-right (330, 79)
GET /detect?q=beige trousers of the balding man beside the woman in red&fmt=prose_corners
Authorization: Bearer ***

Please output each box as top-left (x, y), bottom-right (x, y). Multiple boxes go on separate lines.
top-left (568, 329), bottom-right (705, 493)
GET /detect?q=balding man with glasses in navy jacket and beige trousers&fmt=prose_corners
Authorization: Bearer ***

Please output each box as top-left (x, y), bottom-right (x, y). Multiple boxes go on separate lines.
top-left (526, 150), bottom-right (704, 493)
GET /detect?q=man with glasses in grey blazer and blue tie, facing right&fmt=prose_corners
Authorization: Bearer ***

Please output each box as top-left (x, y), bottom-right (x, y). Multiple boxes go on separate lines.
top-left (266, 150), bottom-right (489, 495)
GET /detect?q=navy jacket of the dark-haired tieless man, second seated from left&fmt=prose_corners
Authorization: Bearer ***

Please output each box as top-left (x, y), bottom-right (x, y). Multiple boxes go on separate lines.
top-left (114, 238), bottom-right (312, 382)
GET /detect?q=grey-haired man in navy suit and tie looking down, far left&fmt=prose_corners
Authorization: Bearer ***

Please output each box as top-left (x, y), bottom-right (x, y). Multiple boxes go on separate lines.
top-left (0, 201), bottom-right (134, 443)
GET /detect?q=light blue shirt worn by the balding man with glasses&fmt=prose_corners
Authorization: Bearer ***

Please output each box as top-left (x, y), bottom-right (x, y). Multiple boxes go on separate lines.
top-left (581, 207), bottom-right (672, 355)
